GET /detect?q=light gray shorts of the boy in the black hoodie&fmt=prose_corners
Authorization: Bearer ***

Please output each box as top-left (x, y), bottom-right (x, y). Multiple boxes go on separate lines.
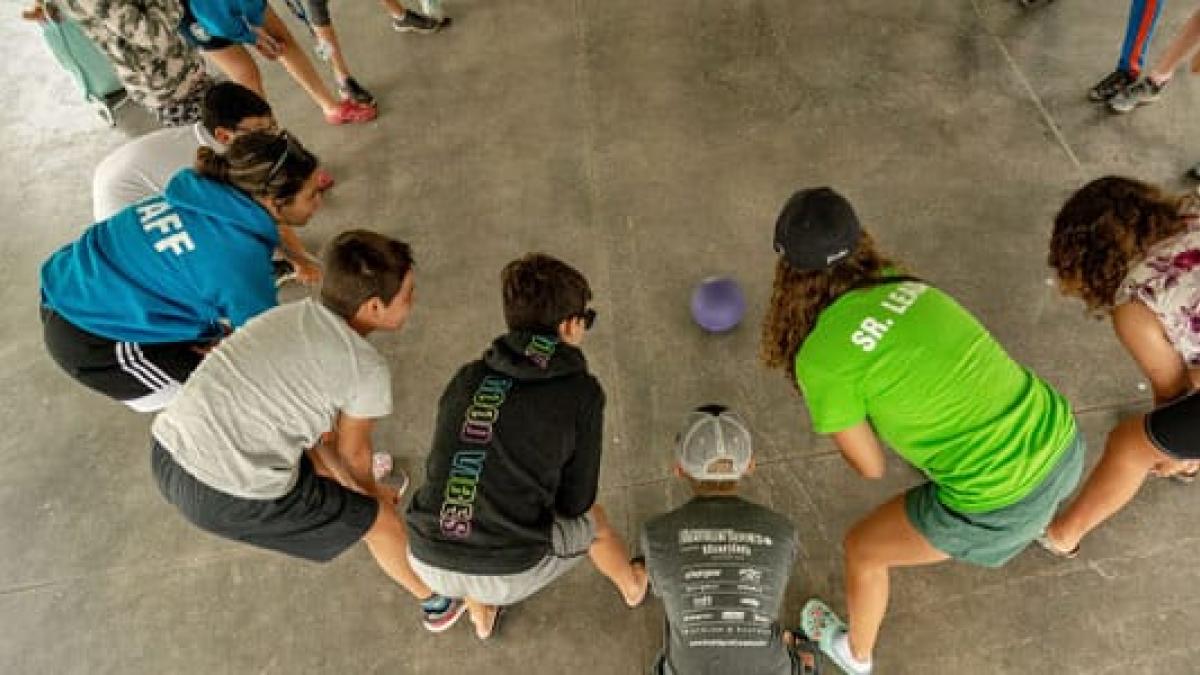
top-left (408, 514), bottom-right (596, 607)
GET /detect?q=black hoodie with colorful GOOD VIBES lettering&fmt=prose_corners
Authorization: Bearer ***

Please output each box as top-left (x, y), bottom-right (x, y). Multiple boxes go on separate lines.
top-left (408, 333), bottom-right (605, 575)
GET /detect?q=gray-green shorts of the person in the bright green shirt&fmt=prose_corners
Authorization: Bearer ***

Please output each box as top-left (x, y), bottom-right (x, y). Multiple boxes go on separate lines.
top-left (905, 432), bottom-right (1085, 567)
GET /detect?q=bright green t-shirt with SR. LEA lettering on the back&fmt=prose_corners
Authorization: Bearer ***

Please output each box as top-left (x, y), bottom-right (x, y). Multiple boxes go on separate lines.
top-left (796, 281), bottom-right (1075, 513)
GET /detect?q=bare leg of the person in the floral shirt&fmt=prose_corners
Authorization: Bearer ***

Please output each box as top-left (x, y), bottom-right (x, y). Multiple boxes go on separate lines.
top-left (1046, 414), bottom-right (1175, 551)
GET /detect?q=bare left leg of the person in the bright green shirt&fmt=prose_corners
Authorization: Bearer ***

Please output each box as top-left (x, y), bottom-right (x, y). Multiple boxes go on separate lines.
top-left (845, 495), bottom-right (949, 661)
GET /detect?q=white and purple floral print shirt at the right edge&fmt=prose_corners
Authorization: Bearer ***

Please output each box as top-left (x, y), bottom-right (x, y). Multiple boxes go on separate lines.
top-left (1116, 219), bottom-right (1200, 368)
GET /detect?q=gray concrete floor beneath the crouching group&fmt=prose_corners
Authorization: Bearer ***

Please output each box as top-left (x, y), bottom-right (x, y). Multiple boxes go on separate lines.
top-left (0, 0), bottom-right (1200, 675)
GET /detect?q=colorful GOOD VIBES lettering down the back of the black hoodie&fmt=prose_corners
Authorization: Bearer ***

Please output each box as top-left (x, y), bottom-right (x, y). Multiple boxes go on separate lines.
top-left (440, 375), bottom-right (512, 539)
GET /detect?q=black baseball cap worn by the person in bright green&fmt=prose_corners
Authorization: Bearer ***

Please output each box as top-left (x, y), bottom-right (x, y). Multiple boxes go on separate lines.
top-left (775, 187), bottom-right (863, 270)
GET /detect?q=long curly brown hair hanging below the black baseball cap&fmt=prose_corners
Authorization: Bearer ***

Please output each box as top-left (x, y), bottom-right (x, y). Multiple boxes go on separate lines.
top-left (758, 232), bottom-right (893, 384)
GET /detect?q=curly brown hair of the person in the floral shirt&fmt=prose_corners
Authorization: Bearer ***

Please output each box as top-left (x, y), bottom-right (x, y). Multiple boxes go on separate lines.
top-left (1046, 175), bottom-right (1189, 312)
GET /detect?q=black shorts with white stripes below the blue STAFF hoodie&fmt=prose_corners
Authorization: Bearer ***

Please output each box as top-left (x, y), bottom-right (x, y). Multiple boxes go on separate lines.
top-left (42, 307), bottom-right (204, 412)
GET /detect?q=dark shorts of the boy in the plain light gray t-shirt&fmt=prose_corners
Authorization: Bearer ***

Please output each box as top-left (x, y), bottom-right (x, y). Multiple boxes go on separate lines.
top-left (150, 441), bottom-right (379, 562)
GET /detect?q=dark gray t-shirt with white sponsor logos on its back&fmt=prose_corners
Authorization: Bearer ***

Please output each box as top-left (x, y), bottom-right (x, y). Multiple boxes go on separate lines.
top-left (642, 496), bottom-right (797, 675)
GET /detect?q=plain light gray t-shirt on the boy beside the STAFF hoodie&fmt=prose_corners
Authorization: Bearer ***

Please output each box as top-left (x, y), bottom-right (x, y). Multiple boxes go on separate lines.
top-left (151, 299), bottom-right (391, 500)
